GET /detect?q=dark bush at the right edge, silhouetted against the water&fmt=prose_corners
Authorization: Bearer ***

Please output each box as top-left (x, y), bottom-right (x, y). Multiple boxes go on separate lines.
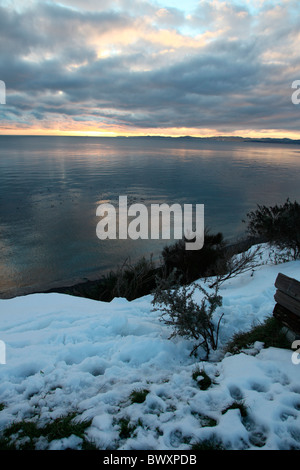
top-left (247, 199), bottom-right (300, 259)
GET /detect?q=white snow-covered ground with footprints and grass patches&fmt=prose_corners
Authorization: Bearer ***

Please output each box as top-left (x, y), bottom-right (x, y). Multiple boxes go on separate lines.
top-left (0, 247), bottom-right (300, 450)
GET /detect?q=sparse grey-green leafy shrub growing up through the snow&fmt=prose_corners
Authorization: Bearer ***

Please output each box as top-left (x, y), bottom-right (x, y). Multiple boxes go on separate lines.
top-left (152, 271), bottom-right (223, 357)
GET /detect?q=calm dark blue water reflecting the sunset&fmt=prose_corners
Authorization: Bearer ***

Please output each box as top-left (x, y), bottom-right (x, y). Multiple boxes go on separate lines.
top-left (0, 136), bottom-right (300, 297)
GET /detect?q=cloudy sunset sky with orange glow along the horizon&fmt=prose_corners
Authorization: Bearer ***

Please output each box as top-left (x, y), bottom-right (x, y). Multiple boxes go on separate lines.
top-left (0, 0), bottom-right (300, 138)
